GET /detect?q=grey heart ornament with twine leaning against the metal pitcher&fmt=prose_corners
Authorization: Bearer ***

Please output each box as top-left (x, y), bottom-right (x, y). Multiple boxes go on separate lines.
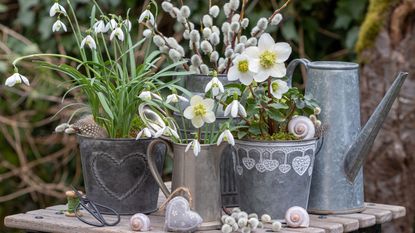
top-left (164, 196), bottom-right (203, 232)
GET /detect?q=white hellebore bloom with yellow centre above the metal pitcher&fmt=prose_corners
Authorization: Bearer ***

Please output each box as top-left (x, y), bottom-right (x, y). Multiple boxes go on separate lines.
top-left (183, 95), bottom-right (216, 128)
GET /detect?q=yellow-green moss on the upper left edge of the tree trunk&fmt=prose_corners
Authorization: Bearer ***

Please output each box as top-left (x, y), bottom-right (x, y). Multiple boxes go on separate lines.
top-left (355, 0), bottom-right (399, 54)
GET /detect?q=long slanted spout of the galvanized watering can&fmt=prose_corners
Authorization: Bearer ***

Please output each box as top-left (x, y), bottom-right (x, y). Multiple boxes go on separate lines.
top-left (344, 72), bottom-right (408, 182)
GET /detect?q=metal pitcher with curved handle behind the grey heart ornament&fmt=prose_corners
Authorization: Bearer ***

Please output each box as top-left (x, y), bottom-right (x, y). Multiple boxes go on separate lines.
top-left (147, 139), bottom-right (226, 230)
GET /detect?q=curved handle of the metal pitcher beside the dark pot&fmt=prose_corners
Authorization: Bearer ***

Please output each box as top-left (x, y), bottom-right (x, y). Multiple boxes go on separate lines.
top-left (147, 139), bottom-right (173, 197)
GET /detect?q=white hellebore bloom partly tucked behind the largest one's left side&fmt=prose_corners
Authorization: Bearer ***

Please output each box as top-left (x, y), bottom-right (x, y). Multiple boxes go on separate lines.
top-left (228, 54), bottom-right (254, 86)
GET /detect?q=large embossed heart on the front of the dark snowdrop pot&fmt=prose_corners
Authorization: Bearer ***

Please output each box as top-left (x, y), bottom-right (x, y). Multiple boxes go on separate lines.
top-left (91, 152), bottom-right (149, 201)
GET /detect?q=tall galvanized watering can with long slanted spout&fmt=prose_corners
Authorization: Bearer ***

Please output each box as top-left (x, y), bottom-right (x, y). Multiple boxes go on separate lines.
top-left (287, 59), bottom-right (408, 214)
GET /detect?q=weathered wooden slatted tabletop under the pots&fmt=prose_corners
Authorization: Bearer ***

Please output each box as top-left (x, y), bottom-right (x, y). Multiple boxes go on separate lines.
top-left (4, 187), bottom-right (406, 233)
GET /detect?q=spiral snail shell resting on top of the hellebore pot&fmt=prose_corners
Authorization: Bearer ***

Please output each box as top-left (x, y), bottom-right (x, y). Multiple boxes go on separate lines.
top-left (288, 116), bottom-right (316, 139)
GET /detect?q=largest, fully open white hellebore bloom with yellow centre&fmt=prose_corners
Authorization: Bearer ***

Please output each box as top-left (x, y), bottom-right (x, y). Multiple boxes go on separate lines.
top-left (245, 33), bottom-right (291, 82)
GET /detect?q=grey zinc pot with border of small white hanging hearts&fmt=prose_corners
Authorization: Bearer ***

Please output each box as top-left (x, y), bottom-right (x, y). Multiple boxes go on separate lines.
top-left (234, 139), bottom-right (317, 219)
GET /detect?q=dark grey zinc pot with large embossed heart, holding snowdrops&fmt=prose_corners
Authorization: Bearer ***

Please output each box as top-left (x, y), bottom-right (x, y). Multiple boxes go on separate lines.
top-left (78, 135), bottom-right (166, 215)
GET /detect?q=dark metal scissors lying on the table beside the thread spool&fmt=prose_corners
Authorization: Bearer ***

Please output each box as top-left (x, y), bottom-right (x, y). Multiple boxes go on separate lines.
top-left (72, 186), bottom-right (120, 227)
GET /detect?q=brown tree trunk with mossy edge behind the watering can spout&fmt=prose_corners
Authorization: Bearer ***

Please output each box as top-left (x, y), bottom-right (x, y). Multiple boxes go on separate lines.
top-left (356, 0), bottom-right (415, 233)
